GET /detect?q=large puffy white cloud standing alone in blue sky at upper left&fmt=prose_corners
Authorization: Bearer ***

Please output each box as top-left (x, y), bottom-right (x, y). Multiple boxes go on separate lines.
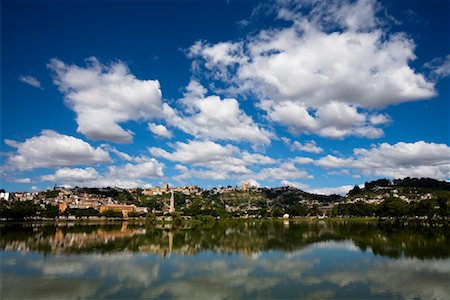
top-left (49, 57), bottom-right (163, 143)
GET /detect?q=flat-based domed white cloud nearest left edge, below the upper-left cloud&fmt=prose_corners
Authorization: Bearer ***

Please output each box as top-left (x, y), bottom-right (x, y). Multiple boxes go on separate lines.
top-left (5, 130), bottom-right (111, 170)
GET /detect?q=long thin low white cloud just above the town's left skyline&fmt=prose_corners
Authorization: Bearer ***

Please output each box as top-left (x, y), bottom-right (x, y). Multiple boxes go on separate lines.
top-left (40, 157), bottom-right (164, 188)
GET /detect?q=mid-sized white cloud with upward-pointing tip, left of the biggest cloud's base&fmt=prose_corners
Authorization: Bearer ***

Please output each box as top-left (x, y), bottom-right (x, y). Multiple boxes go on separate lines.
top-left (164, 80), bottom-right (273, 145)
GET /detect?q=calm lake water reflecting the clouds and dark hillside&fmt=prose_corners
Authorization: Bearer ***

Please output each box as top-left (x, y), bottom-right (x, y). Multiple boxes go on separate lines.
top-left (0, 221), bottom-right (450, 299)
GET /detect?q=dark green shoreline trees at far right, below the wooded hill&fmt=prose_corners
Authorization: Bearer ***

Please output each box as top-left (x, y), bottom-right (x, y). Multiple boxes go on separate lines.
top-left (331, 197), bottom-right (450, 218)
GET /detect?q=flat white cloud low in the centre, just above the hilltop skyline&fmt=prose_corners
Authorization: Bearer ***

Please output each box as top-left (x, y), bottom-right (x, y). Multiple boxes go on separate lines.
top-left (148, 141), bottom-right (276, 180)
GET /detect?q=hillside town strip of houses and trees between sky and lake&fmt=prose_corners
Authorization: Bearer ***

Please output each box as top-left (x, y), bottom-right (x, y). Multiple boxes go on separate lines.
top-left (0, 178), bottom-right (450, 221)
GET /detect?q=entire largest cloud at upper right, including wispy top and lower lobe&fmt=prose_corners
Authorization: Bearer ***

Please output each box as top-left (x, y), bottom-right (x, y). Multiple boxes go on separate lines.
top-left (189, 0), bottom-right (436, 138)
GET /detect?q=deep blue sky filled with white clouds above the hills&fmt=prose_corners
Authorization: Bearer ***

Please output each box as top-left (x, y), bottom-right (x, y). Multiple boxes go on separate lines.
top-left (0, 0), bottom-right (450, 194)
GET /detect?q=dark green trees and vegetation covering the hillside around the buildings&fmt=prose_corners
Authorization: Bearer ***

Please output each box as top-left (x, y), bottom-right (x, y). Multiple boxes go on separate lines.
top-left (0, 178), bottom-right (450, 220)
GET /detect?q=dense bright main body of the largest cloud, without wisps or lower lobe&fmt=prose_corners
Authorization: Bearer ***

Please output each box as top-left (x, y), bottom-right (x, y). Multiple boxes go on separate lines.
top-left (238, 6), bottom-right (435, 108)
